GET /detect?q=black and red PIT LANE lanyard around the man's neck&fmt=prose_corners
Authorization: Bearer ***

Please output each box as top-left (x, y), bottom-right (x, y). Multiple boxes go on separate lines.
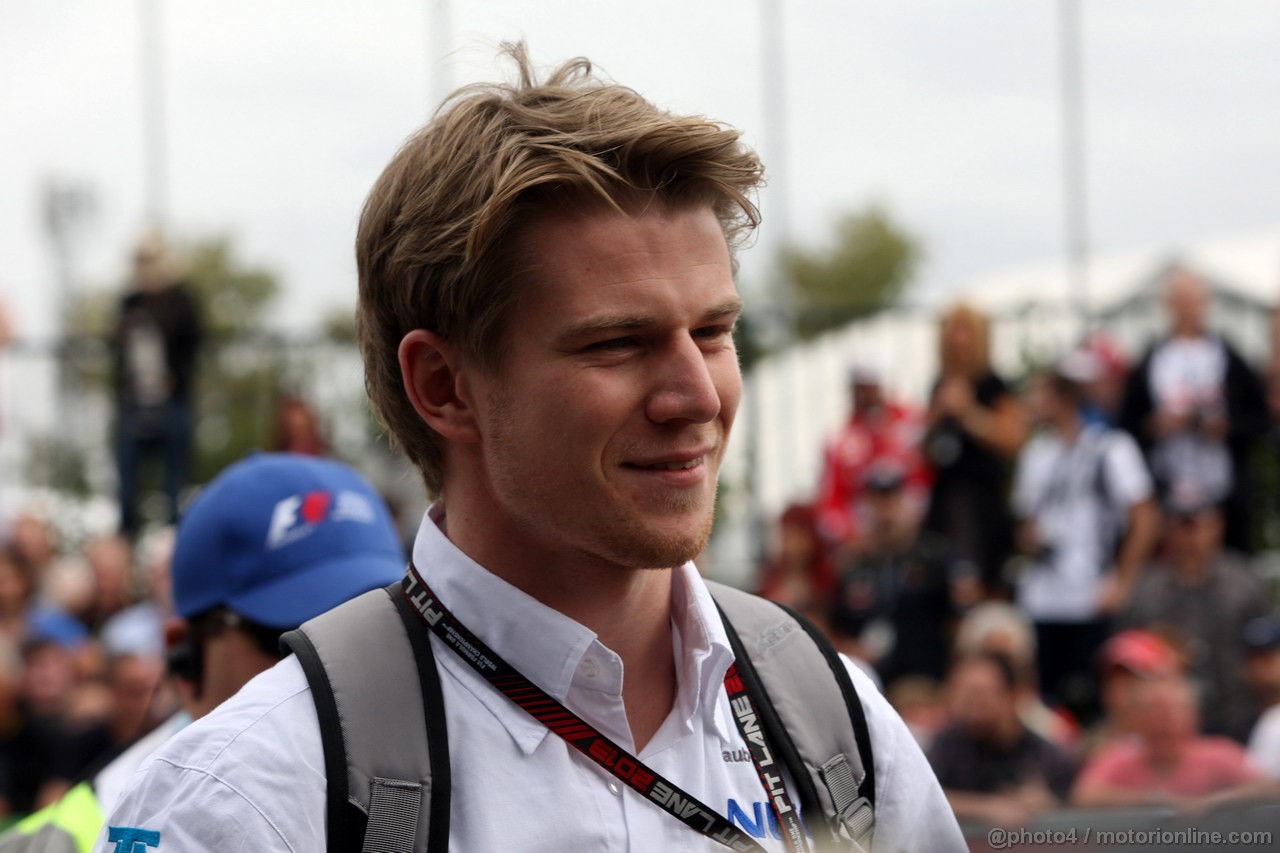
top-left (401, 564), bottom-right (809, 853)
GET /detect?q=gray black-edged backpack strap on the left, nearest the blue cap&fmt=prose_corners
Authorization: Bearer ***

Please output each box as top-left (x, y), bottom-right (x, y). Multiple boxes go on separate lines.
top-left (280, 583), bottom-right (449, 853)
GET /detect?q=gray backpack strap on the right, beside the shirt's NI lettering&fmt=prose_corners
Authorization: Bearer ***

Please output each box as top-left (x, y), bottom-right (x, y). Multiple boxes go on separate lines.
top-left (707, 581), bottom-right (876, 850)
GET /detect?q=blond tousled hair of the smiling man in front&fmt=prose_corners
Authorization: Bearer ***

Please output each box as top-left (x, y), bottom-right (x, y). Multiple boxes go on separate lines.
top-left (356, 45), bottom-right (763, 494)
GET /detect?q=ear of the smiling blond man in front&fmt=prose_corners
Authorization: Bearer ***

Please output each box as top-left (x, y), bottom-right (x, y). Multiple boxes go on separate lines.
top-left (399, 329), bottom-right (480, 443)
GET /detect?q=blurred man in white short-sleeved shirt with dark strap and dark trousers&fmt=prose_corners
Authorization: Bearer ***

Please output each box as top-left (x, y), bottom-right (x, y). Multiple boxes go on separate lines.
top-left (1012, 353), bottom-right (1160, 719)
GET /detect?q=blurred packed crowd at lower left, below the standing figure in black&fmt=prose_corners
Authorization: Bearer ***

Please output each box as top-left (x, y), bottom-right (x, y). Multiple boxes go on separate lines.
top-left (0, 512), bottom-right (177, 817)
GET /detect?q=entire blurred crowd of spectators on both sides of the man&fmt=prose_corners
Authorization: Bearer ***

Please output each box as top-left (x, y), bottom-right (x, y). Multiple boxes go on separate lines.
top-left (0, 238), bottom-right (1280, 826)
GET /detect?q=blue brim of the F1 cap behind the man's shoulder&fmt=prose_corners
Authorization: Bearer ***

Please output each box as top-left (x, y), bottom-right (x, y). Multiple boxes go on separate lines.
top-left (227, 553), bottom-right (404, 630)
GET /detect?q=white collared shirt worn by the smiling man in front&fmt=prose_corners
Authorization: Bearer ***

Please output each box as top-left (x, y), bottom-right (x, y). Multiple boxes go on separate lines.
top-left (96, 507), bottom-right (965, 853)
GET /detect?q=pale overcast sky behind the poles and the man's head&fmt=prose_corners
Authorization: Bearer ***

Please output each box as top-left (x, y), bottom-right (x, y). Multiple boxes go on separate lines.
top-left (0, 0), bottom-right (1280, 336)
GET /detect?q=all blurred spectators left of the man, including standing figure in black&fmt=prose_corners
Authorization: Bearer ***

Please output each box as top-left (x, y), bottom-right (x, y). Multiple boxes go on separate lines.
top-left (0, 234), bottom-right (345, 825)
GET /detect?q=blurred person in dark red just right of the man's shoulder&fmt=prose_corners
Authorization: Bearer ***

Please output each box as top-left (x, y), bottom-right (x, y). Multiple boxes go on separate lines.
top-left (759, 503), bottom-right (833, 614)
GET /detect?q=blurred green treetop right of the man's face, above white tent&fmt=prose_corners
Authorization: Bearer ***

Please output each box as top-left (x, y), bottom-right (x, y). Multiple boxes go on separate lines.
top-left (783, 206), bottom-right (923, 338)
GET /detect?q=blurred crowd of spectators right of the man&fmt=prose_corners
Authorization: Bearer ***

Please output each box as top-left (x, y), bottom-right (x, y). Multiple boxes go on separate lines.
top-left (759, 269), bottom-right (1280, 826)
